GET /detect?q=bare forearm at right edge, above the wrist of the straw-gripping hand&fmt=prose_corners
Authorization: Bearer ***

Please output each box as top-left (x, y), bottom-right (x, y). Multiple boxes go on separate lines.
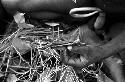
top-left (102, 31), bottom-right (125, 58)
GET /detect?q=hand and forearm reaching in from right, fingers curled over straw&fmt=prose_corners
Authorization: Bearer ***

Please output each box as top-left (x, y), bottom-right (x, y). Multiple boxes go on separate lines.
top-left (63, 23), bottom-right (125, 67)
